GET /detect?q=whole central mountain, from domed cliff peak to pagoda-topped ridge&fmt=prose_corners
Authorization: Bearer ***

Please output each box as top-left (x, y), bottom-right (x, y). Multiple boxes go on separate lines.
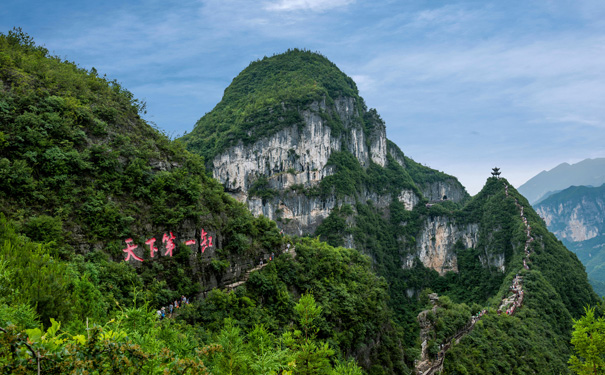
top-left (182, 50), bottom-right (597, 374)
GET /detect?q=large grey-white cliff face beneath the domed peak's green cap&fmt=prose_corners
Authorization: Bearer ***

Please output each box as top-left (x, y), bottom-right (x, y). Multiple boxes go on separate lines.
top-left (212, 97), bottom-right (390, 235)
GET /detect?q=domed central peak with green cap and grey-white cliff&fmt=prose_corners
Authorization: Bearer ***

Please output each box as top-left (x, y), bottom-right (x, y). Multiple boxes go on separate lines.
top-left (183, 50), bottom-right (468, 235)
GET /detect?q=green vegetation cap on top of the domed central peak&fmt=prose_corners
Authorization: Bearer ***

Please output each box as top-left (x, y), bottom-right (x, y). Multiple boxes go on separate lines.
top-left (182, 49), bottom-right (363, 160)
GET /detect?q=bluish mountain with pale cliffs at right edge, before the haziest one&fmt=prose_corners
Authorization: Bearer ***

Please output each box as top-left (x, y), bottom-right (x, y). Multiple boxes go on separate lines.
top-left (535, 184), bottom-right (605, 288)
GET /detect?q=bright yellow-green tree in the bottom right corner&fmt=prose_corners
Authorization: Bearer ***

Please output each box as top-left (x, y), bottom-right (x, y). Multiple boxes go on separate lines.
top-left (568, 307), bottom-right (605, 375)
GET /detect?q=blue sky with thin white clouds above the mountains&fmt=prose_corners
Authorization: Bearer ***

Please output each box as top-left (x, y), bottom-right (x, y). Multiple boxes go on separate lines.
top-left (0, 0), bottom-right (605, 194)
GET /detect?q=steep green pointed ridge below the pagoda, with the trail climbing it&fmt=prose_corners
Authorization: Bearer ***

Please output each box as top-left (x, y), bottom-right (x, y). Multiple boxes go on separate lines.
top-left (444, 181), bottom-right (597, 374)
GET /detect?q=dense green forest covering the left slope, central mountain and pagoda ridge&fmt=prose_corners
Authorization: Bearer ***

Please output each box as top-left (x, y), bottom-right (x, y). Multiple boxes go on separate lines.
top-left (0, 29), bottom-right (597, 375)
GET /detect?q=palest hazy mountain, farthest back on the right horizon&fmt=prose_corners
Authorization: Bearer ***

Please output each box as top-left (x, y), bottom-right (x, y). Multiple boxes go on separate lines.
top-left (519, 158), bottom-right (605, 205)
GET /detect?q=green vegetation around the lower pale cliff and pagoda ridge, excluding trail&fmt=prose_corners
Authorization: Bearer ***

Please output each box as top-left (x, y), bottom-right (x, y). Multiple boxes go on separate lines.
top-left (316, 178), bottom-right (596, 374)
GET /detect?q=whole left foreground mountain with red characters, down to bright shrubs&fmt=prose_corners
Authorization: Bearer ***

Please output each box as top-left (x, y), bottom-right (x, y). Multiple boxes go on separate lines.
top-left (0, 29), bottom-right (406, 374)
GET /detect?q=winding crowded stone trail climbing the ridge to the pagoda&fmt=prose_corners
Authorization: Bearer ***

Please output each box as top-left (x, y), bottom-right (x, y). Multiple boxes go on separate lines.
top-left (416, 181), bottom-right (534, 375)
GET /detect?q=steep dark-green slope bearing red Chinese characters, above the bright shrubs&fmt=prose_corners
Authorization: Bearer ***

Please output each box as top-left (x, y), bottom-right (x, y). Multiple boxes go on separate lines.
top-left (0, 28), bottom-right (290, 295)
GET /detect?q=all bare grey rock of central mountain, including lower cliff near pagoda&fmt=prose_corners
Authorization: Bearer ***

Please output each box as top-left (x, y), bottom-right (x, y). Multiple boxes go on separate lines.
top-left (212, 97), bottom-right (478, 274)
